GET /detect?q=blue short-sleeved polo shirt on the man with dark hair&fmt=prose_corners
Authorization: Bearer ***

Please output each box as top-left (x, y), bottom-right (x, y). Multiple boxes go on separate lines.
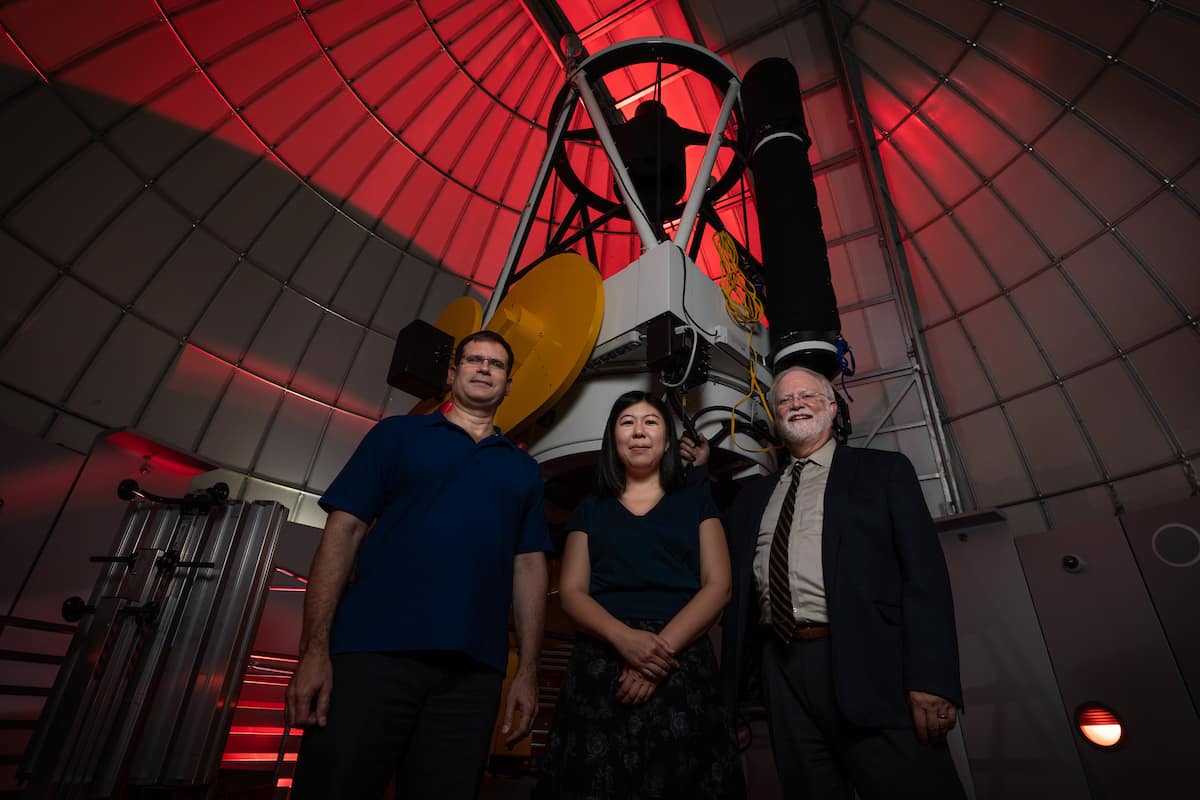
top-left (320, 413), bottom-right (553, 672)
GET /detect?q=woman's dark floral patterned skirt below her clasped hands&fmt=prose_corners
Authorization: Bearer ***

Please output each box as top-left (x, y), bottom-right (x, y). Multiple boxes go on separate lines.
top-left (533, 621), bottom-right (745, 800)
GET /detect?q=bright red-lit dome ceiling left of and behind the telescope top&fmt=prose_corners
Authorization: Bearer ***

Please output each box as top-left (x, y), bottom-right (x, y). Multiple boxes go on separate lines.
top-left (0, 0), bottom-right (742, 284)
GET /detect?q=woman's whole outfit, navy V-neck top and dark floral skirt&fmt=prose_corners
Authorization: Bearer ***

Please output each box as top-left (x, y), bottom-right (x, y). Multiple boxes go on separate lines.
top-left (534, 487), bottom-right (745, 800)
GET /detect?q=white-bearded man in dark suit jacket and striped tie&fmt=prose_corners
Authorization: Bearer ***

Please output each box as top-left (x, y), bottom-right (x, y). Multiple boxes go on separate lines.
top-left (721, 367), bottom-right (964, 800)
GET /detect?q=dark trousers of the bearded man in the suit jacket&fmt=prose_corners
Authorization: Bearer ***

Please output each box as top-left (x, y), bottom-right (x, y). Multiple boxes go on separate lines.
top-left (762, 638), bottom-right (966, 800)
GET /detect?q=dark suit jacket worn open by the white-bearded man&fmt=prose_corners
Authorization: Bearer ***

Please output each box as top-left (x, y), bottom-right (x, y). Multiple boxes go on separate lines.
top-left (721, 445), bottom-right (962, 728)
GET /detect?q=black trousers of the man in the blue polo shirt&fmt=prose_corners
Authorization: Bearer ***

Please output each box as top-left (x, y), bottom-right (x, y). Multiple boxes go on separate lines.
top-left (292, 652), bottom-right (503, 800)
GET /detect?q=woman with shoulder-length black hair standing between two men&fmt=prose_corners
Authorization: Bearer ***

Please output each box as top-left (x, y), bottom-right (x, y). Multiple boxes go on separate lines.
top-left (534, 391), bottom-right (745, 800)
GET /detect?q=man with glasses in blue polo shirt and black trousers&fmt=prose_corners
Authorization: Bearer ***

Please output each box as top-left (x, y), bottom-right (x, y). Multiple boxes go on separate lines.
top-left (287, 331), bottom-right (552, 800)
